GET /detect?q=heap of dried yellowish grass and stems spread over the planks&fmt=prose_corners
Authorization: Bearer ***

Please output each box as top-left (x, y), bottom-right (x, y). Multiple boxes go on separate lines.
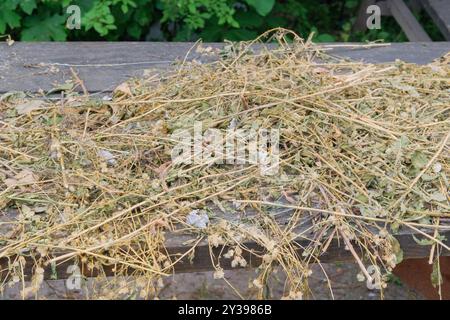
top-left (0, 30), bottom-right (450, 298)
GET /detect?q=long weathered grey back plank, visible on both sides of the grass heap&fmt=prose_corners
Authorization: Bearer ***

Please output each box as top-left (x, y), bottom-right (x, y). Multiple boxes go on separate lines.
top-left (0, 42), bottom-right (450, 93)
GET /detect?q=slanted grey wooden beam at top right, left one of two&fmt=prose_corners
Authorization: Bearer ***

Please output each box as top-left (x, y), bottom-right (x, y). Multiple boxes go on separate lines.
top-left (388, 0), bottom-right (431, 41)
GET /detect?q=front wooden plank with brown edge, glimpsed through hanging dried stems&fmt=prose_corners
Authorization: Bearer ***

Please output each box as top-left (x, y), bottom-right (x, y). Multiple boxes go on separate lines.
top-left (0, 205), bottom-right (450, 282)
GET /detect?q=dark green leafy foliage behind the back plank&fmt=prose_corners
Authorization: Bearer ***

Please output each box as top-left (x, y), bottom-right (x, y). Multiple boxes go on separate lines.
top-left (0, 0), bottom-right (442, 42)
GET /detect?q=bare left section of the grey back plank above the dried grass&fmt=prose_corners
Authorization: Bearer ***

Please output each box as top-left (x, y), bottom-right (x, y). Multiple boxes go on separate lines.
top-left (0, 42), bottom-right (223, 93)
